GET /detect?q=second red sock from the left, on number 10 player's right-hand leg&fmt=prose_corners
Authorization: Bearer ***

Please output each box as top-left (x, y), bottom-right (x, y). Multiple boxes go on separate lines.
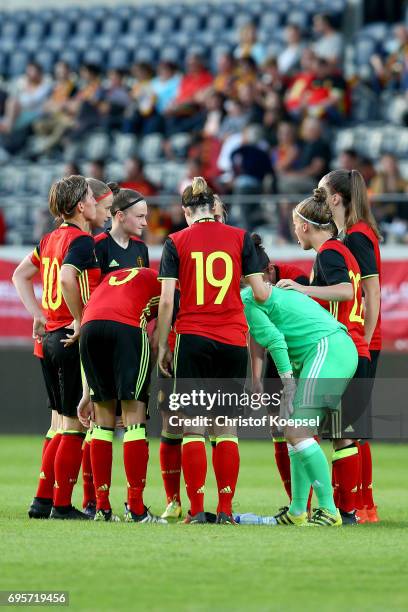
top-left (54, 431), bottom-right (85, 506)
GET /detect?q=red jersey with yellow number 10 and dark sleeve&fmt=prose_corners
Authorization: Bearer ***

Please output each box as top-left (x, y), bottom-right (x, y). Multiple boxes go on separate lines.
top-left (31, 223), bottom-right (101, 331)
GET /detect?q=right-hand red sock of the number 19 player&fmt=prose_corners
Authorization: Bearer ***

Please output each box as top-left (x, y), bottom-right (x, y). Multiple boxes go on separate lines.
top-left (214, 438), bottom-right (239, 515)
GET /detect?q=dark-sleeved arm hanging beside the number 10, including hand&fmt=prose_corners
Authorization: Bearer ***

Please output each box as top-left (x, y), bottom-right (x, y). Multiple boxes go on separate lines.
top-left (60, 236), bottom-right (95, 346)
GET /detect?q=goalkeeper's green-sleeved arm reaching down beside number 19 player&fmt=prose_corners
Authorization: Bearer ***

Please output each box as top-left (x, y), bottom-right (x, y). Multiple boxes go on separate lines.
top-left (245, 303), bottom-right (292, 378)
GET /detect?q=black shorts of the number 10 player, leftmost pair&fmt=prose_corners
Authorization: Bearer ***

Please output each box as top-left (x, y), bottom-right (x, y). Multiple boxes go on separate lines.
top-left (41, 328), bottom-right (82, 418)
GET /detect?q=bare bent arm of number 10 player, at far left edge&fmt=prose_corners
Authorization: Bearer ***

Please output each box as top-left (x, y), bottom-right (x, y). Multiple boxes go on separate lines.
top-left (12, 250), bottom-right (46, 338)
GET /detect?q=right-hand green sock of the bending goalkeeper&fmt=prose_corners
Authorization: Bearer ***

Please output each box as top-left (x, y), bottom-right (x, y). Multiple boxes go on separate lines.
top-left (296, 441), bottom-right (336, 514)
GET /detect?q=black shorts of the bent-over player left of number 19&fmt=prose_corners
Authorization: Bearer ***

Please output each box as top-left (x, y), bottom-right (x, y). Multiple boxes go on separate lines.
top-left (80, 321), bottom-right (150, 404)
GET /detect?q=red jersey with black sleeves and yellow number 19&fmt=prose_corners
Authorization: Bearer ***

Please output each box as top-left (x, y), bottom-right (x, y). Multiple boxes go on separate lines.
top-left (159, 218), bottom-right (261, 346)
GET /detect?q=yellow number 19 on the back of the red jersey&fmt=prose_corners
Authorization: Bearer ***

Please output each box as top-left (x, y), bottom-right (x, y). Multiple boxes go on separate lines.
top-left (191, 251), bottom-right (233, 306)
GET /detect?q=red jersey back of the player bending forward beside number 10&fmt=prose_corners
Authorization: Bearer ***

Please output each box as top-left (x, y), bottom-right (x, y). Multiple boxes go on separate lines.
top-left (82, 268), bottom-right (161, 329)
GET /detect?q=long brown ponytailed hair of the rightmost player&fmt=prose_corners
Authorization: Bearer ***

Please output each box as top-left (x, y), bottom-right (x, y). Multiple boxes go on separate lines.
top-left (322, 170), bottom-right (381, 239)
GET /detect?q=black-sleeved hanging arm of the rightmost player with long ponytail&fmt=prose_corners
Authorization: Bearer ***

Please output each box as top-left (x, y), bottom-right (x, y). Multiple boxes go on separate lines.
top-left (346, 232), bottom-right (381, 344)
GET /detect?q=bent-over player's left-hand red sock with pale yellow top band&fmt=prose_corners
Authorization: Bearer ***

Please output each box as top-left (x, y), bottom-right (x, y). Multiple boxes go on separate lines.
top-left (89, 427), bottom-right (114, 510)
